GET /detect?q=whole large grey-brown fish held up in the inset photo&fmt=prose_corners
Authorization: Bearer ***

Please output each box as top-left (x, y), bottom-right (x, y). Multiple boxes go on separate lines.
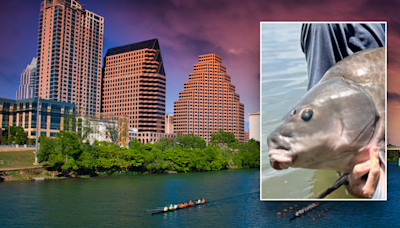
top-left (268, 48), bottom-right (386, 199)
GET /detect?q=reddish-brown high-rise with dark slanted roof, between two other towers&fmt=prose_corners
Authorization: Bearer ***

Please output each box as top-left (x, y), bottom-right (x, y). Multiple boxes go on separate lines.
top-left (101, 39), bottom-right (166, 133)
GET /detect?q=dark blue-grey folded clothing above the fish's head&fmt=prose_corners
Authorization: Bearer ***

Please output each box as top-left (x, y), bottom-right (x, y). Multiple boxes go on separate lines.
top-left (301, 23), bottom-right (385, 90)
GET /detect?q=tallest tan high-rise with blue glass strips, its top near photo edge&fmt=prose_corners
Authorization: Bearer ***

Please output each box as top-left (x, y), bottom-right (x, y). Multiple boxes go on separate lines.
top-left (35, 0), bottom-right (104, 115)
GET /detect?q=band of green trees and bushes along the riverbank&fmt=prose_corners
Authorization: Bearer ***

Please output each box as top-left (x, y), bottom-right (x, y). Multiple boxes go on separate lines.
top-left (3, 130), bottom-right (260, 180)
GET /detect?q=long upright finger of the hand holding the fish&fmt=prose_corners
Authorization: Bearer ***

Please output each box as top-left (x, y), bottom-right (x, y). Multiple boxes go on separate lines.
top-left (363, 146), bottom-right (380, 197)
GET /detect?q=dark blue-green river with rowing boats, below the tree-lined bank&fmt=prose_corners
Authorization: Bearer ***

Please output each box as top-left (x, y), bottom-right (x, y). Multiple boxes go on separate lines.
top-left (0, 163), bottom-right (400, 227)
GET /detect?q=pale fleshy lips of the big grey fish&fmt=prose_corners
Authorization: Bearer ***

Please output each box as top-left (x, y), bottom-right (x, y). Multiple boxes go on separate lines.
top-left (269, 148), bottom-right (296, 170)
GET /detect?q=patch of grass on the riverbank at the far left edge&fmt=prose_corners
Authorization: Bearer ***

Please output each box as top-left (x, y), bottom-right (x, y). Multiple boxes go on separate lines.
top-left (0, 150), bottom-right (35, 168)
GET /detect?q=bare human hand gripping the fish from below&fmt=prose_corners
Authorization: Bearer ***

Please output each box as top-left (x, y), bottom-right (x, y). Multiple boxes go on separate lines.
top-left (347, 146), bottom-right (380, 198)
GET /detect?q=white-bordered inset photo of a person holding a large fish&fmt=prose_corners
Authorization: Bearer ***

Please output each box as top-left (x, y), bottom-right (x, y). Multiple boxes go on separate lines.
top-left (260, 22), bottom-right (387, 201)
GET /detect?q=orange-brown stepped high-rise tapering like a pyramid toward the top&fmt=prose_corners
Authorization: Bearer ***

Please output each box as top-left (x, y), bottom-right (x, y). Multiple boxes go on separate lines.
top-left (174, 54), bottom-right (244, 142)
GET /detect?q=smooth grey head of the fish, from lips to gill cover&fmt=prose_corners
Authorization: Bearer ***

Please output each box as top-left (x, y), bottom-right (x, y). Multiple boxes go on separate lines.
top-left (267, 77), bottom-right (378, 172)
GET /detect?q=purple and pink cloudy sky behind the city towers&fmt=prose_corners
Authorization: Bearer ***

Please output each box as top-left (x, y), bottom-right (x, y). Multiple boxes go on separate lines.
top-left (0, 0), bottom-right (400, 140)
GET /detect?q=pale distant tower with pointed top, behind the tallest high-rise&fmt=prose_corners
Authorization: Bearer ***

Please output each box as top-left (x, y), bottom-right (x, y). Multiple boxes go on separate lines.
top-left (15, 57), bottom-right (37, 100)
